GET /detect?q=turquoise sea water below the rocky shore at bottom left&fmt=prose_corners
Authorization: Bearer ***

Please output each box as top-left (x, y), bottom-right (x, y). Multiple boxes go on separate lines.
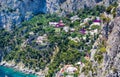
top-left (0, 66), bottom-right (37, 77)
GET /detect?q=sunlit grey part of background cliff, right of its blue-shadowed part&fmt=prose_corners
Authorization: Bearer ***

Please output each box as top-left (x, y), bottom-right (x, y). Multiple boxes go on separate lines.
top-left (47, 0), bottom-right (96, 13)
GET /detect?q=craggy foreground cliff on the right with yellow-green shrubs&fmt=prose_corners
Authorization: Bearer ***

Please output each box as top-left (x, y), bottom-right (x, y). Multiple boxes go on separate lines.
top-left (80, 6), bottom-right (120, 77)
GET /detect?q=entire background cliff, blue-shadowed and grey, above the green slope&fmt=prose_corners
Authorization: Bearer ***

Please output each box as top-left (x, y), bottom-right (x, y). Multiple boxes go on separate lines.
top-left (0, 0), bottom-right (114, 30)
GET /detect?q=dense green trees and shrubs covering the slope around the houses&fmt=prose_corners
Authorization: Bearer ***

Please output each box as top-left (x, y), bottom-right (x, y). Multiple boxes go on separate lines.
top-left (0, 3), bottom-right (118, 77)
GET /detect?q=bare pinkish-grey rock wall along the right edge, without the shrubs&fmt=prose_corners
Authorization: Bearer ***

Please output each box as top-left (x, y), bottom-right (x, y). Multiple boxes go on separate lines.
top-left (106, 17), bottom-right (120, 77)
